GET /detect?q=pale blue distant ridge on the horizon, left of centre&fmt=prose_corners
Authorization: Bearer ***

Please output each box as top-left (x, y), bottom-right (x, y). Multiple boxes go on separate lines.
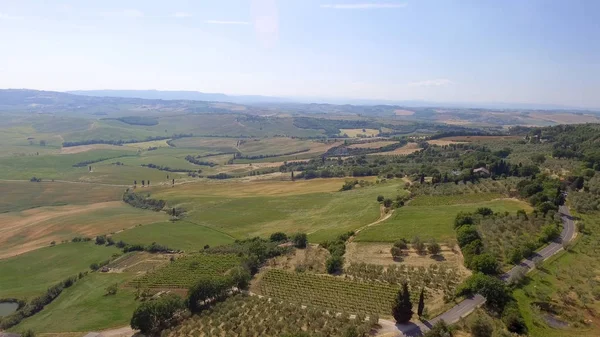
top-left (67, 90), bottom-right (291, 104)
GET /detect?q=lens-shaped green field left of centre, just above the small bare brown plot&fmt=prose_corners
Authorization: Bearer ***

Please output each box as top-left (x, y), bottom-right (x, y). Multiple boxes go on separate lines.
top-left (113, 221), bottom-right (234, 252)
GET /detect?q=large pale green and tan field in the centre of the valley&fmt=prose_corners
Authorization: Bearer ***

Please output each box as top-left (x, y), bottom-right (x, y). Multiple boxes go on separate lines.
top-left (152, 179), bottom-right (406, 242)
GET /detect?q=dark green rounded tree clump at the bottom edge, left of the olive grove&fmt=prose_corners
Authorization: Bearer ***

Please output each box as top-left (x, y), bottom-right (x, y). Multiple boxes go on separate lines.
top-left (130, 294), bottom-right (185, 335)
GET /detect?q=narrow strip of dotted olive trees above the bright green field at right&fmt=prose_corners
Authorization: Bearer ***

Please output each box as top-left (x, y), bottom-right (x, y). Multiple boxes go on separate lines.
top-left (411, 177), bottom-right (522, 196)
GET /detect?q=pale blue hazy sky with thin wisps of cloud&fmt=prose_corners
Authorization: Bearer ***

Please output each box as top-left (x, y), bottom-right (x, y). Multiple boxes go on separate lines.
top-left (0, 0), bottom-right (600, 108)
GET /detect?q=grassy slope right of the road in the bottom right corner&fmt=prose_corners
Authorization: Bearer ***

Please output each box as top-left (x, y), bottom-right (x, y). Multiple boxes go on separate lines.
top-left (514, 212), bottom-right (600, 337)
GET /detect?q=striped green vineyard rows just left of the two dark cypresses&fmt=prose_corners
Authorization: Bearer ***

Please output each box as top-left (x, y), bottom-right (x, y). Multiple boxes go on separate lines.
top-left (260, 269), bottom-right (400, 315)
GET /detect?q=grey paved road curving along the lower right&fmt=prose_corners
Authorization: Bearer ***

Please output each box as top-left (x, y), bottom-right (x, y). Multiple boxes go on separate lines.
top-left (390, 206), bottom-right (575, 336)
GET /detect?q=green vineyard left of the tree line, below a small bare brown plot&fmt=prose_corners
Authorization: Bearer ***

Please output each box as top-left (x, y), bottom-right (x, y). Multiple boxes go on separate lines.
top-left (129, 254), bottom-right (240, 288)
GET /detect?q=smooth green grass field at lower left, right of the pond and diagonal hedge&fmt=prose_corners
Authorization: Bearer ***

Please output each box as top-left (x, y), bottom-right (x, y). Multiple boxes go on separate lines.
top-left (11, 273), bottom-right (138, 333)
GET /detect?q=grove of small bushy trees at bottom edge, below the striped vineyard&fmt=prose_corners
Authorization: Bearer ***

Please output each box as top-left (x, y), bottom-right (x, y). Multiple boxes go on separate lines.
top-left (162, 295), bottom-right (378, 337)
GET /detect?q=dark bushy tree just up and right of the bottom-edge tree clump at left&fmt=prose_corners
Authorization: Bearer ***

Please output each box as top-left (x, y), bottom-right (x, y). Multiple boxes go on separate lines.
top-left (187, 277), bottom-right (231, 313)
